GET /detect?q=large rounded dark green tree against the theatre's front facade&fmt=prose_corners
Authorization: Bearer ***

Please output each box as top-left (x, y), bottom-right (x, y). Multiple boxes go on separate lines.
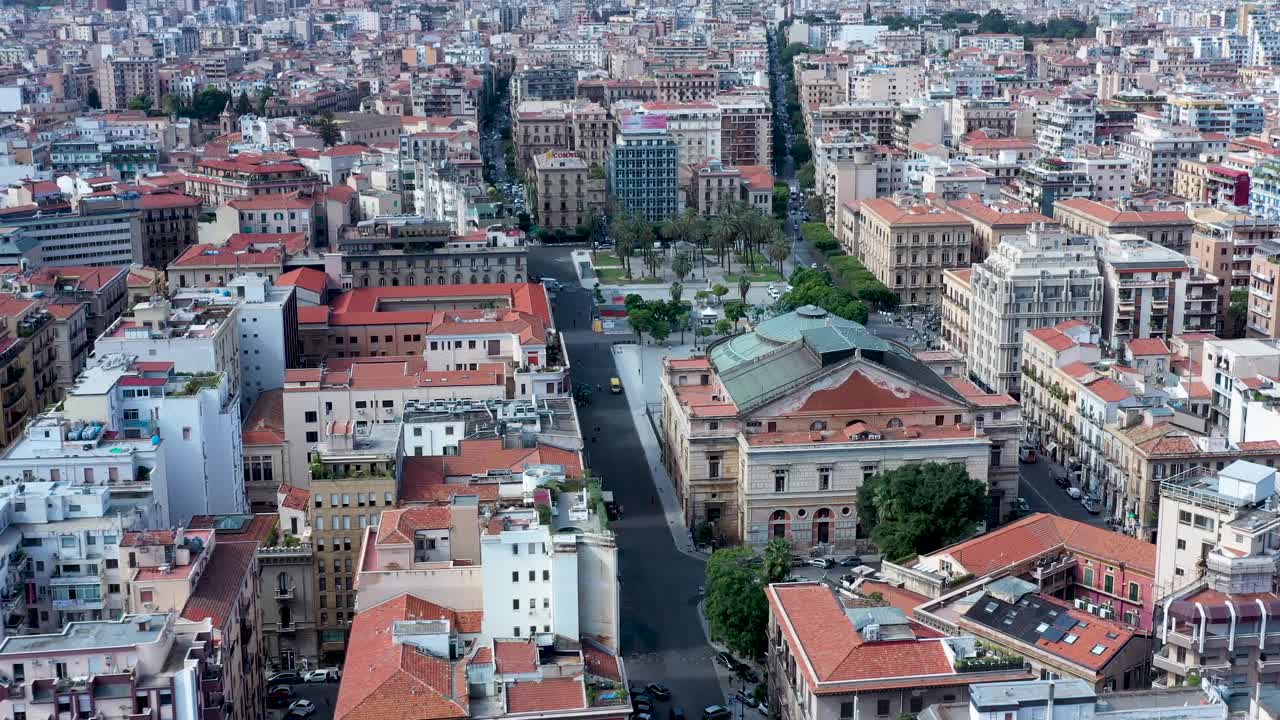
top-left (858, 462), bottom-right (987, 560)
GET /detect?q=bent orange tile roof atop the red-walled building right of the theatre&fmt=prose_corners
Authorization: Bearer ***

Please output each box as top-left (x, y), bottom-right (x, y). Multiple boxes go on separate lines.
top-left (929, 512), bottom-right (1156, 577)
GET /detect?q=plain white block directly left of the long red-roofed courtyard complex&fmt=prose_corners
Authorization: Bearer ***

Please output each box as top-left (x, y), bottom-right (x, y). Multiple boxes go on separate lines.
top-left (174, 274), bottom-right (300, 413)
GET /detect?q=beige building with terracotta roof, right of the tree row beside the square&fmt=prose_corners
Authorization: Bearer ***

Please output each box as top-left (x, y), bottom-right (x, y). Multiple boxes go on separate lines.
top-left (856, 197), bottom-right (973, 307)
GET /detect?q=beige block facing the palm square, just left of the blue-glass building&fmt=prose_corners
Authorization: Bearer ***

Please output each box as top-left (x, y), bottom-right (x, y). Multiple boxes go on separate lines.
top-left (531, 151), bottom-right (605, 231)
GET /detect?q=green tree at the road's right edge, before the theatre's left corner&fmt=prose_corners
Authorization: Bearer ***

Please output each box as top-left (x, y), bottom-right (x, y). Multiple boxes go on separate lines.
top-left (704, 547), bottom-right (769, 657)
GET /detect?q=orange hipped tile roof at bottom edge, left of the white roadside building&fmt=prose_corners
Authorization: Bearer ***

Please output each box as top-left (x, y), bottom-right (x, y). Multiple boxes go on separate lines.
top-left (333, 593), bottom-right (470, 720)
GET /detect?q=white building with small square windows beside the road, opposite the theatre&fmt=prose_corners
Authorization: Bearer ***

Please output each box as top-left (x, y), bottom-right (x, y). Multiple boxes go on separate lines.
top-left (480, 465), bottom-right (620, 650)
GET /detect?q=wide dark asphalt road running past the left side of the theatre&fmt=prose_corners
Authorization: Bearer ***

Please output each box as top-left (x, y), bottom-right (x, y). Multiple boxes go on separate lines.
top-left (529, 247), bottom-right (724, 717)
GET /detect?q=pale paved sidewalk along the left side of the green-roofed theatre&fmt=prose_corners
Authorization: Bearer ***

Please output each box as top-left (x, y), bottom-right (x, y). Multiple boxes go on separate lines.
top-left (613, 345), bottom-right (708, 562)
